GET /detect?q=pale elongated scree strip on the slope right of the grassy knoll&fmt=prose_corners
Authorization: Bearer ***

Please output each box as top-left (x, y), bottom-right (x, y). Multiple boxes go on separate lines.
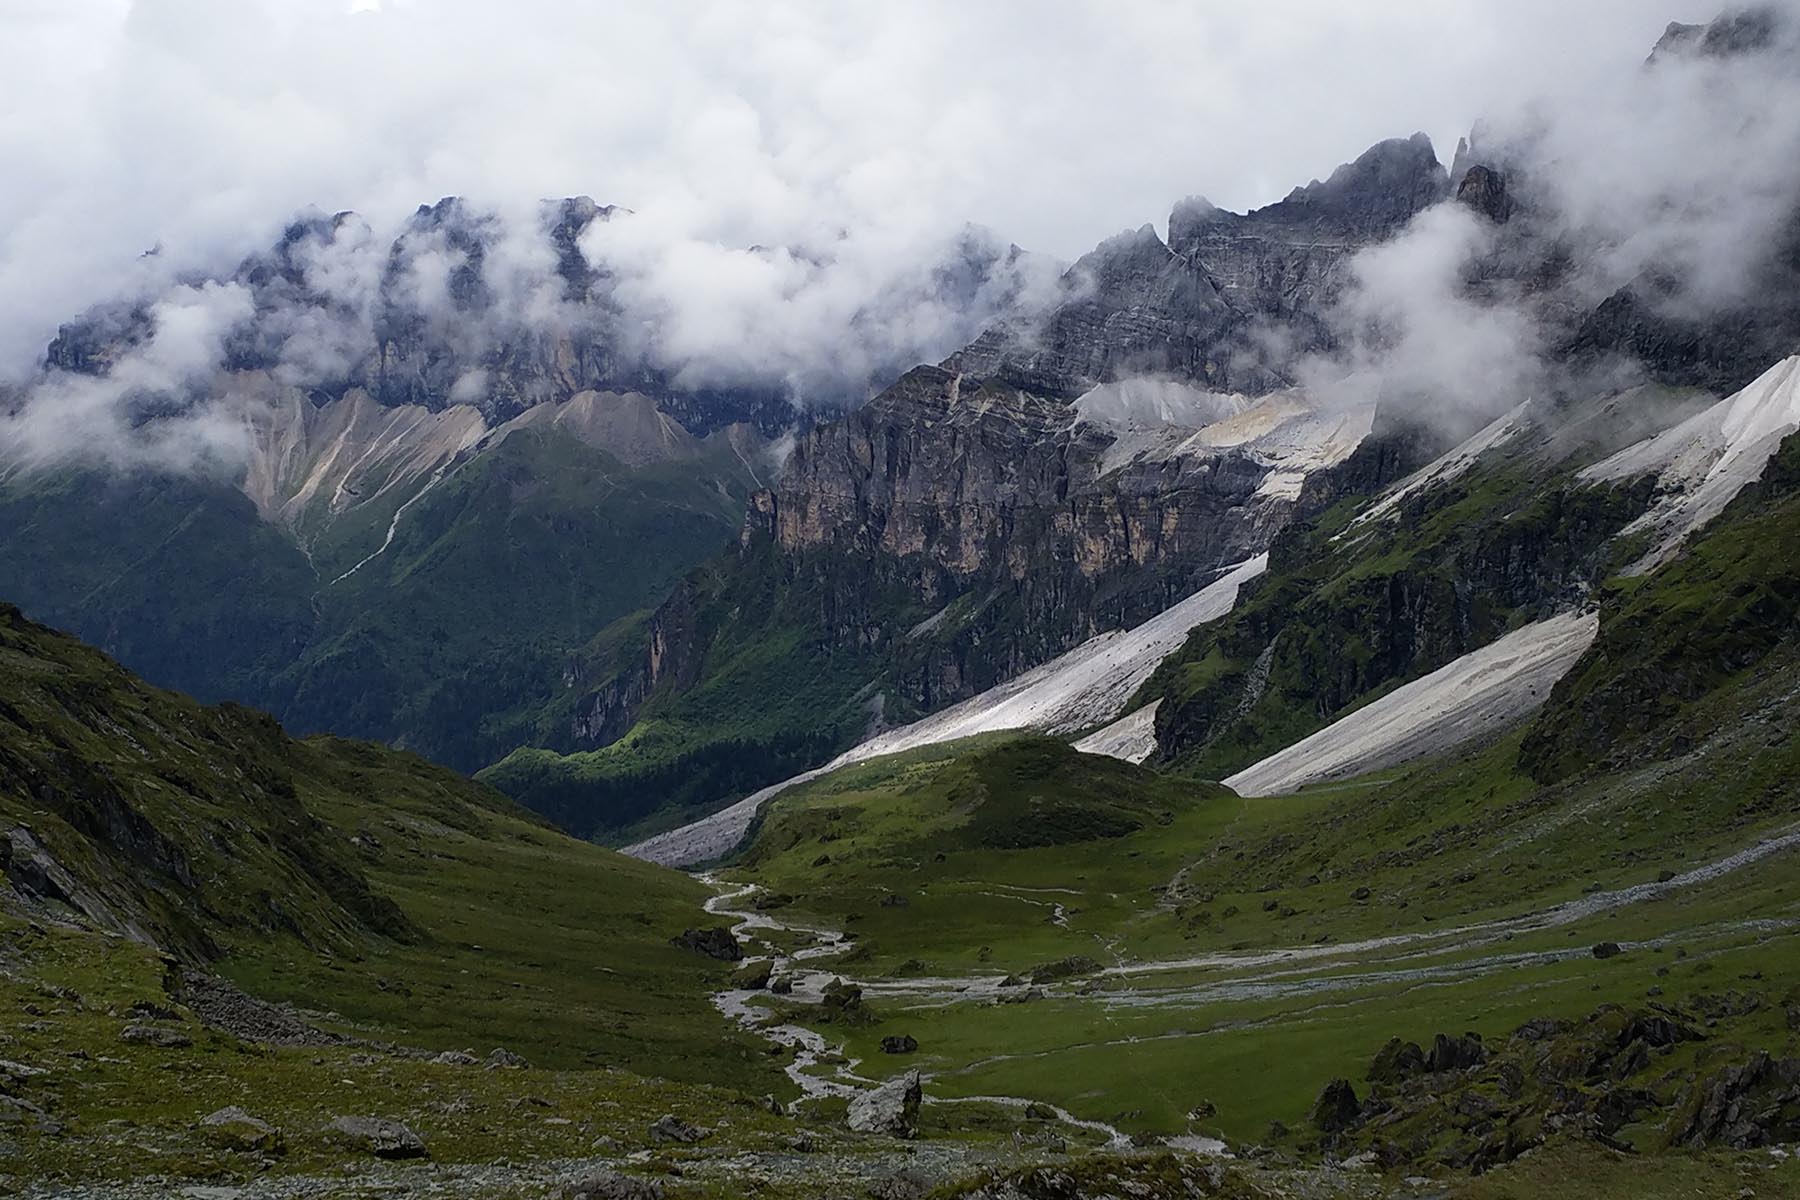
top-left (1224, 612), bottom-right (1600, 795)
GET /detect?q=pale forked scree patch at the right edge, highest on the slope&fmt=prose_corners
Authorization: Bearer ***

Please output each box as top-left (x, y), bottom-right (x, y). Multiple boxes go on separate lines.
top-left (1580, 354), bottom-right (1800, 576)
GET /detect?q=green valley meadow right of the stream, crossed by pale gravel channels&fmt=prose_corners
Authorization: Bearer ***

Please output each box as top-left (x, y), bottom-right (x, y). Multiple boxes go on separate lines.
top-left (734, 655), bottom-right (1800, 1141)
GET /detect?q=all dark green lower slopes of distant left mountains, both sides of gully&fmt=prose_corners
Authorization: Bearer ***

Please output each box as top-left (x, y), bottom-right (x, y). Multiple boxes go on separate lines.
top-left (0, 428), bottom-right (752, 770)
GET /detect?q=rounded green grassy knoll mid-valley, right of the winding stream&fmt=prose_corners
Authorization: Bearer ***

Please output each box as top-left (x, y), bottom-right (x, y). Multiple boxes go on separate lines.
top-left (736, 736), bottom-right (1235, 975)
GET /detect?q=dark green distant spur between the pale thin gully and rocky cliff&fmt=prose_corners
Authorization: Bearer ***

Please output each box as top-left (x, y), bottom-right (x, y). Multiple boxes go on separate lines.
top-left (268, 430), bottom-right (751, 770)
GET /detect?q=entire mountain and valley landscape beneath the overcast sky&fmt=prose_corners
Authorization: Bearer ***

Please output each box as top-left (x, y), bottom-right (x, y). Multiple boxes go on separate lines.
top-left (0, 9), bottom-right (1800, 1200)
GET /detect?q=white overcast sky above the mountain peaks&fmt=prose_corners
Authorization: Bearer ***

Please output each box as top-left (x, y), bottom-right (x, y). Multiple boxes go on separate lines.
top-left (0, 0), bottom-right (1719, 371)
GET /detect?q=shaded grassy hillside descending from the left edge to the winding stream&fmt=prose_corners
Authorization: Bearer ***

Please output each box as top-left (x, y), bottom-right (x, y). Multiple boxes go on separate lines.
top-left (0, 608), bottom-right (769, 1087)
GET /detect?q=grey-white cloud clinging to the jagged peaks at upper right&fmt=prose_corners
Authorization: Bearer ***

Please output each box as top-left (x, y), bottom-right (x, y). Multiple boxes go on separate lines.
top-left (1300, 0), bottom-right (1800, 434)
